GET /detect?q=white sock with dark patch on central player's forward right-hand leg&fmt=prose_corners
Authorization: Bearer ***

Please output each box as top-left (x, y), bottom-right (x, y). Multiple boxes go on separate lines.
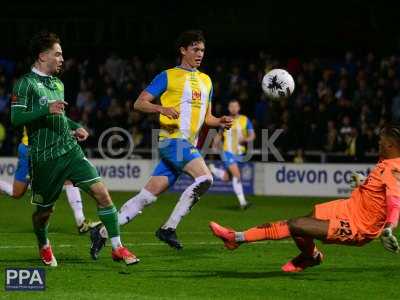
top-left (162, 175), bottom-right (213, 229)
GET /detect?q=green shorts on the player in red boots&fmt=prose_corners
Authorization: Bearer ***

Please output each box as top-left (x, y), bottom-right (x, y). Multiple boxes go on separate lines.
top-left (30, 146), bottom-right (101, 208)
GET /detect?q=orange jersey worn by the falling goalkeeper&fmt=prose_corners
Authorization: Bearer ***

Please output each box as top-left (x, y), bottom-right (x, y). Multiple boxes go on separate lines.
top-left (347, 158), bottom-right (400, 238)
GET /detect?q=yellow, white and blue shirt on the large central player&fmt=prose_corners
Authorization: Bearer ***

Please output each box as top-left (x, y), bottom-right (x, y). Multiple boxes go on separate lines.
top-left (146, 67), bottom-right (212, 144)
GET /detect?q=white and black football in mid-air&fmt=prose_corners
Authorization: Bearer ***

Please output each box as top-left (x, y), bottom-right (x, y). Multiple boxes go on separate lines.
top-left (262, 69), bottom-right (294, 100)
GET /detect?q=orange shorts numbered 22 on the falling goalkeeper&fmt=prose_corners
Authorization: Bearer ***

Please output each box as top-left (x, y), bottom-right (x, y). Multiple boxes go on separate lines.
top-left (314, 199), bottom-right (371, 246)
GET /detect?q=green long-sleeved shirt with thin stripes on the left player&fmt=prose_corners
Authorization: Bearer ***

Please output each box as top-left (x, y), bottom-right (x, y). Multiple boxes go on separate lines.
top-left (11, 69), bottom-right (81, 162)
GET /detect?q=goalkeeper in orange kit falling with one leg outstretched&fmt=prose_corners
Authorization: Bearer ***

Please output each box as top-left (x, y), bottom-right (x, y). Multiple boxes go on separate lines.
top-left (210, 125), bottom-right (400, 272)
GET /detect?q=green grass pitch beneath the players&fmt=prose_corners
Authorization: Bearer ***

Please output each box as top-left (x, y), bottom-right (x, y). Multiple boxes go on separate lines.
top-left (0, 193), bottom-right (400, 300)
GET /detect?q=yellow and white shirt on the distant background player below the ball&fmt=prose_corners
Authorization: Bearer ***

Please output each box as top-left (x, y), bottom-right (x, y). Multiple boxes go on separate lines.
top-left (223, 115), bottom-right (254, 155)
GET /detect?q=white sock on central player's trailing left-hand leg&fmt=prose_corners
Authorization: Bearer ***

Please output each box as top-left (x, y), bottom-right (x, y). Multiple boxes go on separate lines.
top-left (118, 189), bottom-right (157, 225)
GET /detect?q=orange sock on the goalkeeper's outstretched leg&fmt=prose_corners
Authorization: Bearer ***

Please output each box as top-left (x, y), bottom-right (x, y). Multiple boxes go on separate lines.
top-left (243, 221), bottom-right (290, 242)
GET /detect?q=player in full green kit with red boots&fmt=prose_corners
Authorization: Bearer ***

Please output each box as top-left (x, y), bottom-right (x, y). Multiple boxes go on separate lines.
top-left (11, 32), bottom-right (139, 266)
